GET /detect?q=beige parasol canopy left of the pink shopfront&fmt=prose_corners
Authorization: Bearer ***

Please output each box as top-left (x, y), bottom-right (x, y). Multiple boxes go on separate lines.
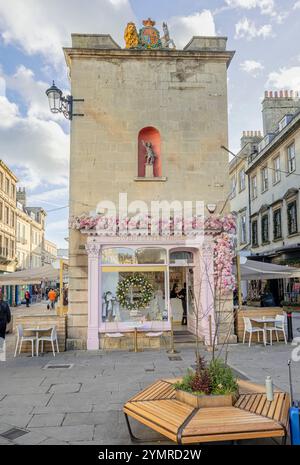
top-left (0, 265), bottom-right (65, 286)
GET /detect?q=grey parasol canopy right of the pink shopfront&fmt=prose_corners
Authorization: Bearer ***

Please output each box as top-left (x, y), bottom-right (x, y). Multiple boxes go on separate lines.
top-left (234, 258), bottom-right (300, 281)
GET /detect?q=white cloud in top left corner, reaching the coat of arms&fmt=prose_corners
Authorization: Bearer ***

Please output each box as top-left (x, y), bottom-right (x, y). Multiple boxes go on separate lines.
top-left (0, 0), bottom-right (134, 65)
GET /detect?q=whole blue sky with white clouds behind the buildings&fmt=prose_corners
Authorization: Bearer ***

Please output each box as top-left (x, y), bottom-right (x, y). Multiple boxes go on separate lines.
top-left (0, 0), bottom-right (300, 247)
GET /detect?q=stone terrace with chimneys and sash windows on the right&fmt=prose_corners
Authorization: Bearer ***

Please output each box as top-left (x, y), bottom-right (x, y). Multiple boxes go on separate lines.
top-left (230, 91), bottom-right (300, 302)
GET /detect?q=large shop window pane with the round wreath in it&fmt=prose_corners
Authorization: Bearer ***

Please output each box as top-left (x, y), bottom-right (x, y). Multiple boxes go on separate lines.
top-left (101, 270), bottom-right (168, 322)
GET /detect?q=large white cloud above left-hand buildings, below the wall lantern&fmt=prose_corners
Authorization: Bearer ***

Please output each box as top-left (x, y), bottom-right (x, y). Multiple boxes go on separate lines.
top-left (0, 70), bottom-right (69, 188)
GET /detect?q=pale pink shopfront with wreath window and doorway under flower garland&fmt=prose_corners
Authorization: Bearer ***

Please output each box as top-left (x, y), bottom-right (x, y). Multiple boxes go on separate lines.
top-left (86, 235), bottom-right (213, 350)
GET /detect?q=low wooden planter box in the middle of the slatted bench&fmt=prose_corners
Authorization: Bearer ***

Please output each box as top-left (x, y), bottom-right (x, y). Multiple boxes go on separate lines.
top-left (176, 389), bottom-right (236, 408)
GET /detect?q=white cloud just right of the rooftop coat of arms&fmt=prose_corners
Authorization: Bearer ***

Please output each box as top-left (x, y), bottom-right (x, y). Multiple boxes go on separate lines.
top-left (168, 10), bottom-right (216, 48)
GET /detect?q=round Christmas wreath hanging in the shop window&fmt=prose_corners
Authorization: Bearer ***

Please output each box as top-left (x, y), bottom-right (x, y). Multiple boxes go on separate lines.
top-left (116, 273), bottom-right (153, 310)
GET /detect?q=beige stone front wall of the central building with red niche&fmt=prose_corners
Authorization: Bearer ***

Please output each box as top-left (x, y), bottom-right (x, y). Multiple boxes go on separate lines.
top-left (64, 28), bottom-right (233, 348)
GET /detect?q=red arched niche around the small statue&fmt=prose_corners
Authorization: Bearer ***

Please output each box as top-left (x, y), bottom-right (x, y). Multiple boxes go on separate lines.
top-left (138, 126), bottom-right (162, 178)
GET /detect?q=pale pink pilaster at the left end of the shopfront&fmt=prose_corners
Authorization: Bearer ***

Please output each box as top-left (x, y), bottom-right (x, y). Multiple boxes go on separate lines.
top-left (85, 240), bottom-right (101, 350)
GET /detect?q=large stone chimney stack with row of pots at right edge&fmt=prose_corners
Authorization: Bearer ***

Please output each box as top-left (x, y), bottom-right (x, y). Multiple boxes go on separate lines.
top-left (262, 90), bottom-right (300, 135)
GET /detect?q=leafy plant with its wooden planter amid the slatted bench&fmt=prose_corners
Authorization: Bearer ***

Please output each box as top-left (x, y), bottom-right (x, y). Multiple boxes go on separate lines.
top-left (175, 356), bottom-right (238, 408)
